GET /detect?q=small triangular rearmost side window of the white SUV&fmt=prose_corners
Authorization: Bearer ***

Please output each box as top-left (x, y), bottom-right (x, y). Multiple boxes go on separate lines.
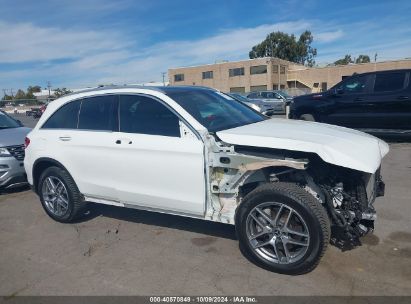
top-left (42, 100), bottom-right (81, 129)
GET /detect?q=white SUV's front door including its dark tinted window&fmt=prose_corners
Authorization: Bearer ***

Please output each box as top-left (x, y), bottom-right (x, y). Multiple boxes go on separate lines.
top-left (115, 95), bottom-right (205, 216)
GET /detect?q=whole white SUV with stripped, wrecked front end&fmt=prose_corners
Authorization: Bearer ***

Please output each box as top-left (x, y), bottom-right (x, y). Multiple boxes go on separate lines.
top-left (24, 86), bottom-right (388, 274)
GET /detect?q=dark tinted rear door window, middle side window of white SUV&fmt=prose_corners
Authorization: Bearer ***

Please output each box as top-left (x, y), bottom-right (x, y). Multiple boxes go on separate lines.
top-left (78, 95), bottom-right (118, 131)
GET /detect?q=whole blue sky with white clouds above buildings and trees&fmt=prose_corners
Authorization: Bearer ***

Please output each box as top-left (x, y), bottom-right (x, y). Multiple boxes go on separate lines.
top-left (0, 0), bottom-right (411, 92)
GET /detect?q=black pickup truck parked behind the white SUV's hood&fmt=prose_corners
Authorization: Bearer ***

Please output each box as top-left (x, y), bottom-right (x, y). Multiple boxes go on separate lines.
top-left (290, 70), bottom-right (411, 135)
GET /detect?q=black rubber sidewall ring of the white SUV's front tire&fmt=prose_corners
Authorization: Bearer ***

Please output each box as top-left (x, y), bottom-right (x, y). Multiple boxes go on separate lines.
top-left (236, 185), bottom-right (324, 274)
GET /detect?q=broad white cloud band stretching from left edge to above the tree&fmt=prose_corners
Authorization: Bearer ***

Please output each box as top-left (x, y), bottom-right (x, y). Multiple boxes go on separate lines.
top-left (0, 21), bottom-right (310, 87)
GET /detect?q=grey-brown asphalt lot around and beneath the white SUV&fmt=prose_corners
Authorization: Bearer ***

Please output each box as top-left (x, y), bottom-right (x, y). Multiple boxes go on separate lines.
top-left (0, 118), bottom-right (411, 296)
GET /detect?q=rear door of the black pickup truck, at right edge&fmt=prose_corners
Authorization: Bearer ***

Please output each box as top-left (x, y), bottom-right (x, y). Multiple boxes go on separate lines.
top-left (366, 70), bottom-right (411, 130)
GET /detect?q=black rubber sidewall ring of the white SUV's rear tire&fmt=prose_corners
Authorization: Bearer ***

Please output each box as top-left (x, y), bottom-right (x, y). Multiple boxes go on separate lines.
top-left (38, 167), bottom-right (74, 223)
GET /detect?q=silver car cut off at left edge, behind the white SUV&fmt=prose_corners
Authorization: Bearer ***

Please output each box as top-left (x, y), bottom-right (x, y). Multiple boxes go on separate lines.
top-left (0, 111), bottom-right (30, 191)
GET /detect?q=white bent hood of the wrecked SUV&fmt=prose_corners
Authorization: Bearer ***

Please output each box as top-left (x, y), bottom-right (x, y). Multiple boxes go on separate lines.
top-left (217, 118), bottom-right (389, 173)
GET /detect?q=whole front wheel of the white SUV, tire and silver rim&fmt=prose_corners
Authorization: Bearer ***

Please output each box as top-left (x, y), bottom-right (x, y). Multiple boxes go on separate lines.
top-left (235, 182), bottom-right (330, 275)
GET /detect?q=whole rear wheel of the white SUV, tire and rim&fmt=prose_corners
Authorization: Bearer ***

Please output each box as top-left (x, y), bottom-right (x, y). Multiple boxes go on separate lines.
top-left (37, 167), bottom-right (85, 223)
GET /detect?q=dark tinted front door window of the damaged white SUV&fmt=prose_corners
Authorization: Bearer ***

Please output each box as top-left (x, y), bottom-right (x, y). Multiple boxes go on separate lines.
top-left (120, 95), bottom-right (180, 137)
